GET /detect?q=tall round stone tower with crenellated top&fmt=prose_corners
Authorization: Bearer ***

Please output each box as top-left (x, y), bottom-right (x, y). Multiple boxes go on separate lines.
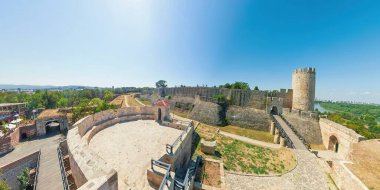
top-left (292, 68), bottom-right (315, 111)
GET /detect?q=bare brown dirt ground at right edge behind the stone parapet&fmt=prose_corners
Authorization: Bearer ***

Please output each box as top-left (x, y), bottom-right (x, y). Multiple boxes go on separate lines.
top-left (346, 139), bottom-right (380, 189)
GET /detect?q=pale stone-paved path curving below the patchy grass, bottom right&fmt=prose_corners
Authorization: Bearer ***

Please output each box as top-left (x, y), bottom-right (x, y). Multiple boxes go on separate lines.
top-left (226, 150), bottom-right (329, 190)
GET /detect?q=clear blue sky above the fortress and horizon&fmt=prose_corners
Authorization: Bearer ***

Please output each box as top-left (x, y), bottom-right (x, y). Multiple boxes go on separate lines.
top-left (0, 0), bottom-right (380, 103)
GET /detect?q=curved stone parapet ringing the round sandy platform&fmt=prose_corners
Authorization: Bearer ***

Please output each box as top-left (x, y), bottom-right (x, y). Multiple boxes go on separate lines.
top-left (67, 107), bottom-right (194, 190)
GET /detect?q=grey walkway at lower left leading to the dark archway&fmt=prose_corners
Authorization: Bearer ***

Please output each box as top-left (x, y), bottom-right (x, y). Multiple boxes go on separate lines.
top-left (0, 134), bottom-right (63, 190)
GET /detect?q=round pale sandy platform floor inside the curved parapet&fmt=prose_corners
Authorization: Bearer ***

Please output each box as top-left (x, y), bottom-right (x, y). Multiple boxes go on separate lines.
top-left (89, 120), bottom-right (182, 189)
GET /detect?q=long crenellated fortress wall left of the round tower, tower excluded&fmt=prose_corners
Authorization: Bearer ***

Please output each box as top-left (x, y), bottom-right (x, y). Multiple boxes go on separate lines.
top-left (158, 87), bottom-right (293, 131)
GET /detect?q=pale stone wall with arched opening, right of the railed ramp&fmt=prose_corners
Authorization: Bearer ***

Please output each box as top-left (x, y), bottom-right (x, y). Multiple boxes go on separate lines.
top-left (319, 118), bottom-right (364, 159)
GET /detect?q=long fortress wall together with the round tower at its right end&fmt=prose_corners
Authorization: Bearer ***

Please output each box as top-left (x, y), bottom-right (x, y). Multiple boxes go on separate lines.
top-left (154, 68), bottom-right (322, 144)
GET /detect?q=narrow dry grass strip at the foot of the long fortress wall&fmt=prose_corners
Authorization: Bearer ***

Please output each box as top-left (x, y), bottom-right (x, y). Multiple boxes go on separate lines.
top-left (219, 125), bottom-right (273, 143)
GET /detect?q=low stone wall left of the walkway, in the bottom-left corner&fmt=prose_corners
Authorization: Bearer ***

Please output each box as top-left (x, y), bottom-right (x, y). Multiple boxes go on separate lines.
top-left (0, 151), bottom-right (40, 190)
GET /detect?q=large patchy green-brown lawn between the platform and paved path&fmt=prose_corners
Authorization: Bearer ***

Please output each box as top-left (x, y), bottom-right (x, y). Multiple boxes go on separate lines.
top-left (193, 125), bottom-right (296, 174)
